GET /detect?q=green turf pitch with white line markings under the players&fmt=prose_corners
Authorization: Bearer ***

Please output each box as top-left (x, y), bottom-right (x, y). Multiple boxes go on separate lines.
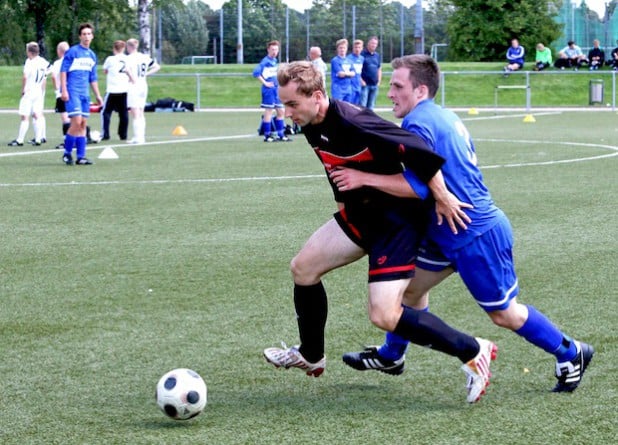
top-left (0, 108), bottom-right (618, 445)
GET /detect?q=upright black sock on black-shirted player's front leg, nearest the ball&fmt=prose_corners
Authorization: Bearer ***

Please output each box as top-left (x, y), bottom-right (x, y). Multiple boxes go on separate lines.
top-left (294, 281), bottom-right (328, 363)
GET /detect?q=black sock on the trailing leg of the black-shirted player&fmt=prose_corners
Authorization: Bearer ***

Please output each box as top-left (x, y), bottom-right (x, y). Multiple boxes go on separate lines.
top-left (394, 307), bottom-right (479, 363)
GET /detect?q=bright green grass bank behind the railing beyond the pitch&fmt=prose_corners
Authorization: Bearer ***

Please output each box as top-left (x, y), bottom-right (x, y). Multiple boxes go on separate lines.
top-left (0, 60), bottom-right (616, 109)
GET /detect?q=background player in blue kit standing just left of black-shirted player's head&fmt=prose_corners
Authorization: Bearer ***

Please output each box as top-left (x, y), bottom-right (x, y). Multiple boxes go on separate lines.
top-left (253, 40), bottom-right (290, 142)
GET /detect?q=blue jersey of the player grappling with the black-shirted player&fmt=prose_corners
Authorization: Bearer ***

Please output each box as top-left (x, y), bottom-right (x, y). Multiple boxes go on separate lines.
top-left (402, 99), bottom-right (502, 252)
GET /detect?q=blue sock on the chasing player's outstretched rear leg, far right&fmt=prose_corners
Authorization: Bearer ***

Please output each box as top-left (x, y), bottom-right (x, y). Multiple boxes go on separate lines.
top-left (515, 306), bottom-right (577, 362)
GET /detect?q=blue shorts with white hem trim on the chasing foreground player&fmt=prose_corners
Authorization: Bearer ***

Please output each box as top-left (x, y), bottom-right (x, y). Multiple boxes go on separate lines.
top-left (416, 217), bottom-right (519, 312)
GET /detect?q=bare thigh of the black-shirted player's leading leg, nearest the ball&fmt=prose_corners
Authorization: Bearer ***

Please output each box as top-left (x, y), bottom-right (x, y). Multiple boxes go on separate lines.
top-left (291, 218), bottom-right (365, 284)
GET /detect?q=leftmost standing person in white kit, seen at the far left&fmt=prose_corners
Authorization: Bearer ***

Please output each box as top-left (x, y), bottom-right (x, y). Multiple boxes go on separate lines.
top-left (8, 42), bottom-right (50, 147)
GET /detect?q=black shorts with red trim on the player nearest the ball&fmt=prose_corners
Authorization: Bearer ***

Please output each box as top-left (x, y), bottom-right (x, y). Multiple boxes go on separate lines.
top-left (334, 206), bottom-right (428, 283)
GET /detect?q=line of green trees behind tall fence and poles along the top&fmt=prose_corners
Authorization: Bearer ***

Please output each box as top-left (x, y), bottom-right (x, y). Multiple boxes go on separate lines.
top-left (0, 0), bottom-right (616, 65)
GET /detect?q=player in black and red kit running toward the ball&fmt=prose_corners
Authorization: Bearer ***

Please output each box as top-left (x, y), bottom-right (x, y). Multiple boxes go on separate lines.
top-left (264, 62), bottom-right (497, 402)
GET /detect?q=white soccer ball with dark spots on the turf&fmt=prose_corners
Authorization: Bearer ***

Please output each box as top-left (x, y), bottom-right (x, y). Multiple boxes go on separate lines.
top-left (155, 368), bottom-right (207, 420)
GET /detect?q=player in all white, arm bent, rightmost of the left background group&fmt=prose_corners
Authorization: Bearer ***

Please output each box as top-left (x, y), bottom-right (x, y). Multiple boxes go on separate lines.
top-left (126, 39), bottom-right (161, 144)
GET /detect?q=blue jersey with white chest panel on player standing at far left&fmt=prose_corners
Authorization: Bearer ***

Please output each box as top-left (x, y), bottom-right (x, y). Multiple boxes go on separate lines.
top-left (60, 44), bottom-right (97, 96)
